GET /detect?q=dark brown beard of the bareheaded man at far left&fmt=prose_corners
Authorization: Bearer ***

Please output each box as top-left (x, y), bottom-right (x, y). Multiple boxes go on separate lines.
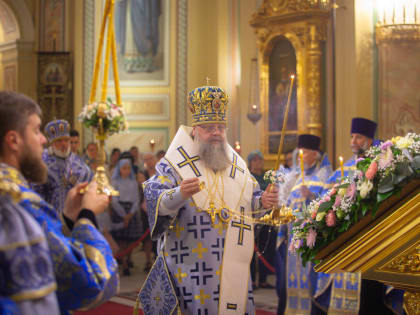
top-left (19, 143), bottom-right (48, 184)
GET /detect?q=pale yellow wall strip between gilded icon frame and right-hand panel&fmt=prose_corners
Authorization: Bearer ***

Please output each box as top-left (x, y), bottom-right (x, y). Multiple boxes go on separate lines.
top-left (334, 0), bottom-right (376, 167)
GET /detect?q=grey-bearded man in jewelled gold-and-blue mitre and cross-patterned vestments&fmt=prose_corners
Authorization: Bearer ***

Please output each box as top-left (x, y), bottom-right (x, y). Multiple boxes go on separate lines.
top-left (139, 86), bottom-right (278, 315)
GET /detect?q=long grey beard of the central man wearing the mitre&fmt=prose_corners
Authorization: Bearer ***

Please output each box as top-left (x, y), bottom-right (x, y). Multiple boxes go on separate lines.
top-left (194, 133), bottom-right (230, 172)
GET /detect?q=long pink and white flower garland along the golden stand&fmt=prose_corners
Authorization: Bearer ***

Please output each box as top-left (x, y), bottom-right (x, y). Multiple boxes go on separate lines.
top-left (289, 133), bottom-right (420, 264)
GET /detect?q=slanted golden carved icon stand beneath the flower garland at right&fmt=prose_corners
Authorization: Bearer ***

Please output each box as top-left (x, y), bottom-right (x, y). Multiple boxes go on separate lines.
top-left (315, 179), bottom-right (420, 315)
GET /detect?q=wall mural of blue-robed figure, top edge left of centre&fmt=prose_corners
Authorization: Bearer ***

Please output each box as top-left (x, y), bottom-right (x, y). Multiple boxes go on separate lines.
top-left (110, 0), bottom-right (170, 86)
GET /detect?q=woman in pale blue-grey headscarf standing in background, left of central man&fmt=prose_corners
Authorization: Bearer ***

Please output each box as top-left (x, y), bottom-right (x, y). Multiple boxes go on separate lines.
top-left (111, 154), bottom-right (143, 276)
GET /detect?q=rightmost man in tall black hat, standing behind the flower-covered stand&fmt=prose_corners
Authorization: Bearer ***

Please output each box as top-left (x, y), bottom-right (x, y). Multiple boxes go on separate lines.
top-left (314, 117), bottom-right (403, 315)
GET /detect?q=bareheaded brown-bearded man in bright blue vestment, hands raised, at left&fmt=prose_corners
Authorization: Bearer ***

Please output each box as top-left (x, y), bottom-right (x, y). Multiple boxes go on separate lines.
top-left (0, 92), bottom-right (119, 314)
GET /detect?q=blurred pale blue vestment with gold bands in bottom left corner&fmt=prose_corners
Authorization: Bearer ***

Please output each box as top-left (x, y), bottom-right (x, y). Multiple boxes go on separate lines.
top-left (0, 180), bottom-right (60, 315)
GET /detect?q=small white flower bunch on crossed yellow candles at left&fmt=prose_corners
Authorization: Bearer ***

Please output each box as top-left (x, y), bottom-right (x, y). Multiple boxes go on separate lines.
top-left (79, 99), bottom-right (128, 135)
